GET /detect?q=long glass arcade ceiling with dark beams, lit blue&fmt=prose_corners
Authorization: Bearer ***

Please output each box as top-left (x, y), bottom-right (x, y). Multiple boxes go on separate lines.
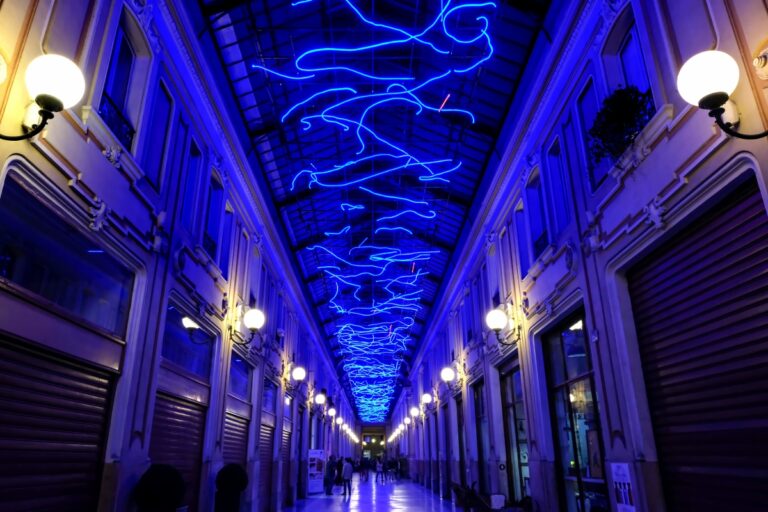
top-left (199, 0), bottom-right (549, 423)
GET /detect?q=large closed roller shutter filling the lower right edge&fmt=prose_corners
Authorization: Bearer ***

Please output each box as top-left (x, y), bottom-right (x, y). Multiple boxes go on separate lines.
top-left (627, 181), bottom-right (768, 512)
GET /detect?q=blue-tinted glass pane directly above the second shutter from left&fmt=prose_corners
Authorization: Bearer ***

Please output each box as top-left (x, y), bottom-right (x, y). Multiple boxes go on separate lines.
top-left (162, 305), bottom-right (216, 382)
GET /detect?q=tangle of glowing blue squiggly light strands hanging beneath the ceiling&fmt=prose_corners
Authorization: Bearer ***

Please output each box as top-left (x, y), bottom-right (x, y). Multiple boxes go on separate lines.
top-left (264, 1), bottom-right (496, 422)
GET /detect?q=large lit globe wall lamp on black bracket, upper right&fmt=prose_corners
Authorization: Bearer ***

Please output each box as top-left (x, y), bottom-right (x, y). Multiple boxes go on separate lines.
top-left (677, 50), bottom-right (768, 139)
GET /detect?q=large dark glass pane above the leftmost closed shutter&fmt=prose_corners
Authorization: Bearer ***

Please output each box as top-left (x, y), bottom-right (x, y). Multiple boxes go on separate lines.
top-left (0, 174), bottom-right (134, 336)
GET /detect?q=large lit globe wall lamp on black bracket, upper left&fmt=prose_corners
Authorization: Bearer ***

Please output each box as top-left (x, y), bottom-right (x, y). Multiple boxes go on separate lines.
top-left (0, 54), bottom-right (85, 140)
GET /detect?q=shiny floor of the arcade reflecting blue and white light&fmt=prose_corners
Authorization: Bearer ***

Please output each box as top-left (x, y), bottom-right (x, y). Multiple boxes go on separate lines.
top-left (283, 475), bottom-right (460, 512)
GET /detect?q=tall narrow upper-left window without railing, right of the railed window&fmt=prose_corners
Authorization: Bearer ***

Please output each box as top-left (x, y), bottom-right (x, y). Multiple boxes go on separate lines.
top-left (144, 81), bottom-right (173, 189)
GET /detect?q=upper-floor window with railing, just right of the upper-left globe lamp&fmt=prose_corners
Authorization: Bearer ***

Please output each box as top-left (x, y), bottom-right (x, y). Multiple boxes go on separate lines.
top-left (99, 25), bottom-right (136, 149)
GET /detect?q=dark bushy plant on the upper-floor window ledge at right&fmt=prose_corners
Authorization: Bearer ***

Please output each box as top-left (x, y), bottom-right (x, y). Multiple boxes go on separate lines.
top-left (589, 85), bottom-right (655, 163)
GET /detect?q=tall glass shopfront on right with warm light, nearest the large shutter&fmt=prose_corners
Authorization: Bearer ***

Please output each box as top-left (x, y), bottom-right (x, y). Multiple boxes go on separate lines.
top-left (544, 316), bottom-right (610, 512)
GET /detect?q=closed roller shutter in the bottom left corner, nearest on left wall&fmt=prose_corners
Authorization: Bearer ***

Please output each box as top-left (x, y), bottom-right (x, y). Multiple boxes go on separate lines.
top-left (0, 339), bottom-right (115, 512)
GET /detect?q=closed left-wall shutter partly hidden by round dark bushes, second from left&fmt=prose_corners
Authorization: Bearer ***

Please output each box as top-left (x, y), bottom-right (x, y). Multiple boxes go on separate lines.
top-left (149, 393), bottom-right (205, 512)
